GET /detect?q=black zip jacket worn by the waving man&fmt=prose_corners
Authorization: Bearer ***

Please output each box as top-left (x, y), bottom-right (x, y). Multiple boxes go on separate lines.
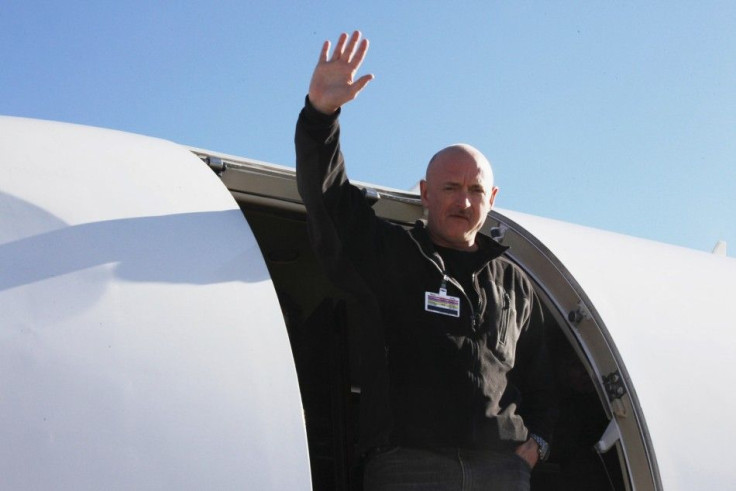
top-left (295, 101), bottom-right (555, 449)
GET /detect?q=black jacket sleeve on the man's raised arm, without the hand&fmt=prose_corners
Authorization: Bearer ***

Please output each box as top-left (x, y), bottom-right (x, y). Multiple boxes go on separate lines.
top-left (294, 98), bottom-right (380, 292)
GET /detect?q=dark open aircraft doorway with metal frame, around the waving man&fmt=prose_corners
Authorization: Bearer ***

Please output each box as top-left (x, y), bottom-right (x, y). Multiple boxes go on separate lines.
top-left (206, 152), bottom-right (661, 491)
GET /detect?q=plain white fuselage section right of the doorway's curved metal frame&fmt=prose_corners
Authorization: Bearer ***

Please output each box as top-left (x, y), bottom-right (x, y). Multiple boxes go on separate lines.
top-left (500, 210), bottom-right (736, 490)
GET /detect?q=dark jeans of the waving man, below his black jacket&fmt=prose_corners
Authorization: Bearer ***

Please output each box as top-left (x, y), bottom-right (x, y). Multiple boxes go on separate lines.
top-left (363, 447), bottom-right (531, 491)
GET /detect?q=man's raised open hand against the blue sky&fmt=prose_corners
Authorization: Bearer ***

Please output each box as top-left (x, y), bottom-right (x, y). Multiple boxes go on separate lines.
top-left (309, 31), bottom-right (373, 114)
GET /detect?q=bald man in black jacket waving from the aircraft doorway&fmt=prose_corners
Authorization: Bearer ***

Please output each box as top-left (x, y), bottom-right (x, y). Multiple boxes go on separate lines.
top-left (295, 31), bottom-right (555, 491)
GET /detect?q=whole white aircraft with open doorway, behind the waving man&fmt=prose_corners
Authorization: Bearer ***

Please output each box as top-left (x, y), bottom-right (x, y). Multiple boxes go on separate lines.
top-left (0, 117), bottom-right (736, 491)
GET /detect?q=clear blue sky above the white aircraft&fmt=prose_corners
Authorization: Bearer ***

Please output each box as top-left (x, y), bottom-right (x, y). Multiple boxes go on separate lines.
top-left (0, 0), bottom-right (736, 256)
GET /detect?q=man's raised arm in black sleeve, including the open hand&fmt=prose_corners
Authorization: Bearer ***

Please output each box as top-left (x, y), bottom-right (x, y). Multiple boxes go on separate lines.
top-left (294, 31), bottom-right (377, 290)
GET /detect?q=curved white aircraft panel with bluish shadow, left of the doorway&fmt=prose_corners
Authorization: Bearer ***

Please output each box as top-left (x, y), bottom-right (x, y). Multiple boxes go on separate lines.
top-left (0, 118), bottom-right (311, 490)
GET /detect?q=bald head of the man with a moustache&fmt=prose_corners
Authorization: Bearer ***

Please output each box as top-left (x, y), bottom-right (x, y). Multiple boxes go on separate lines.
top-left (420, 148), bottom-right (498, 250)
